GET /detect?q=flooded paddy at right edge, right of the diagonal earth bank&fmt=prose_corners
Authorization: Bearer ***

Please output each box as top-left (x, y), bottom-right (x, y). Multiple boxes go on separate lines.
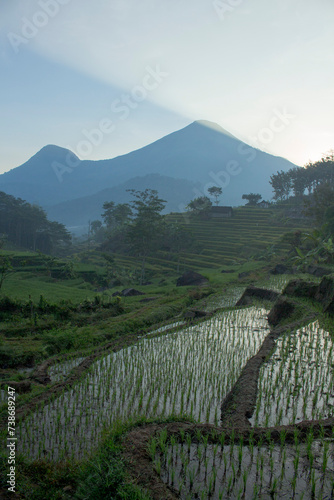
top-left (250, 321), bottom-right (334, 427)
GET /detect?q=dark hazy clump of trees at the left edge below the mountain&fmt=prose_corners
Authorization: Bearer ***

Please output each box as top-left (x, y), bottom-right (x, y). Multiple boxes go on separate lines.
top-left (0, 191), bottom-right (71, 254)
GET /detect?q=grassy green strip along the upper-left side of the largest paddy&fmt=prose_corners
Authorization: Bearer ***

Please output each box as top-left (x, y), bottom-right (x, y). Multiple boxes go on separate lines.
top-left (0, 286), bottom-right (210, 369)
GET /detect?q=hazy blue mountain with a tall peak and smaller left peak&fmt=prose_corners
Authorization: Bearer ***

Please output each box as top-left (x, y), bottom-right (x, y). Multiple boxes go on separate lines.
top-left (0, 121), bottom-right (295, 229)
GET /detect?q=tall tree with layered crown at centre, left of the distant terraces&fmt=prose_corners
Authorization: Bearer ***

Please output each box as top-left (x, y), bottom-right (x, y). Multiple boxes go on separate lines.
top-left (127, 189), bottom-right (166, 284)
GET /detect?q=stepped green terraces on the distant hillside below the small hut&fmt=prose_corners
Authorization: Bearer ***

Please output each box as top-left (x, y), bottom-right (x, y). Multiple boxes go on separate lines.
top-left (116, 207), bottom-right (304, 272)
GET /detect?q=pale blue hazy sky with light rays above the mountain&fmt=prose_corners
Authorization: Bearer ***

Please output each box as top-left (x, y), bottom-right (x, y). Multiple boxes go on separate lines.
top-left (0, 0), bottom-right (334, 172)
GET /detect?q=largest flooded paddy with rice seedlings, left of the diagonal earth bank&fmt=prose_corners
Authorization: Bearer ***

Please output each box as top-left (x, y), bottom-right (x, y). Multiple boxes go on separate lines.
top-left (18, 307), bottom-right (269, 460)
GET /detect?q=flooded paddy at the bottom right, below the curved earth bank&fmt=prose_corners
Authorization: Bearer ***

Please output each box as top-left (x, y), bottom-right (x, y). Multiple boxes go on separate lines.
top-left (154, 431), bottom-right (334, 500)
